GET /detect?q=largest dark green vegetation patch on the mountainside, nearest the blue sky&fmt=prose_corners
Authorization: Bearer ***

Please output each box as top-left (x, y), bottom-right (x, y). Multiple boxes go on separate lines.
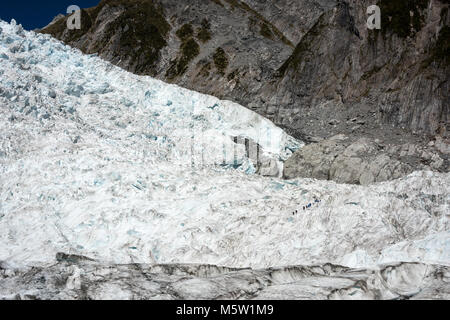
top-left (42, 0), bottom-right (170, 75)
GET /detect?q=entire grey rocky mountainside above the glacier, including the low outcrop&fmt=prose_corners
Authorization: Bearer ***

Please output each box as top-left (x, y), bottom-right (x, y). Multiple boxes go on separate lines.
top-left (41, 0), bottom-right (450, 183)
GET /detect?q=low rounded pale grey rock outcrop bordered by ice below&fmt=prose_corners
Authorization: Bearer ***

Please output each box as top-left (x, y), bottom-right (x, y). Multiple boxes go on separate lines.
top-left (283, 135), bottom-right (448, 185)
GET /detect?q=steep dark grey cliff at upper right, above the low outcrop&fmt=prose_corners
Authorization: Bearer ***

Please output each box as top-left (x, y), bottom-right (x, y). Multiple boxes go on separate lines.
top-left (255, 0), bottom-right (450, 135)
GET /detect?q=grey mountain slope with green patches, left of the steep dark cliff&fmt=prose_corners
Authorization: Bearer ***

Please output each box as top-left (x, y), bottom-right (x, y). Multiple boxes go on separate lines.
top-left (42, 0), bottom-right (294, 103)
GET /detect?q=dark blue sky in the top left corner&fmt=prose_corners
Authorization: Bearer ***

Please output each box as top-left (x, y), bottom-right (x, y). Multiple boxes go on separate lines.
top-left (0, 0), bottom-right (100, 30)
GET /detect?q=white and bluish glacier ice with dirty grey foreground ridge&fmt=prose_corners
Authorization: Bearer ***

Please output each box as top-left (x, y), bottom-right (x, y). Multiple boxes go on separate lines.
top-left (0, 21), bottom-right (450, 299)
